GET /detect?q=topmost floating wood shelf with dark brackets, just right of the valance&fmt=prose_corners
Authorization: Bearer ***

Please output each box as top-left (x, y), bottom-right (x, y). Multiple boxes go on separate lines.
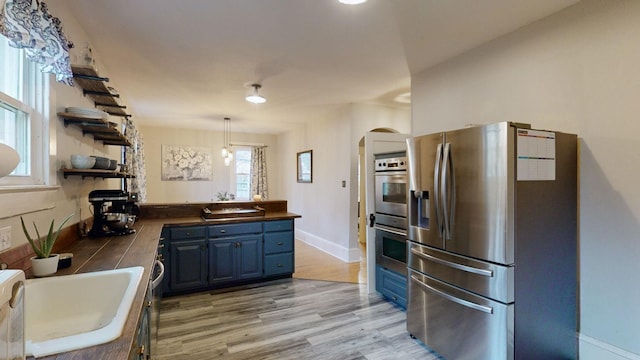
top-left (71, 65), bottom-right (131, 117)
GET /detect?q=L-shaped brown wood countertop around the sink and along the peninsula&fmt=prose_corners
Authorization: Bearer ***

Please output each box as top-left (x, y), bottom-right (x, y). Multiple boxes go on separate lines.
top-left (38, 201), bottom-right (300, 360)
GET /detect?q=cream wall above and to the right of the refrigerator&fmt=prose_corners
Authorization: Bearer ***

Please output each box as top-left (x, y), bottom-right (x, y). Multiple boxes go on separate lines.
top-left (412, 0), bottom-right (640, 359)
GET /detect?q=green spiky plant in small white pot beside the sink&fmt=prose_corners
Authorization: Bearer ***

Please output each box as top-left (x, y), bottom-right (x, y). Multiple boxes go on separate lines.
top-left (20, 214), bottom-right (74, 277)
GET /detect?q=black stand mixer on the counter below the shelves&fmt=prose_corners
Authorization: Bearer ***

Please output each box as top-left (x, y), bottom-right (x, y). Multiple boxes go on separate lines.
top-left (89, 190), bottom-right (139, 237)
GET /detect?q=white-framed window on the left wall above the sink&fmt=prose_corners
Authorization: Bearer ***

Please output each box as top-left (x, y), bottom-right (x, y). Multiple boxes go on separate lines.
top-left (0, 36), bottom-right (48, 185)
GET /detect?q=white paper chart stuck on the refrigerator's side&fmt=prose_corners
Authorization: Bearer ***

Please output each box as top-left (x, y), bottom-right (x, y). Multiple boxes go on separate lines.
top-left (517, 129), bottom-right (556, 181)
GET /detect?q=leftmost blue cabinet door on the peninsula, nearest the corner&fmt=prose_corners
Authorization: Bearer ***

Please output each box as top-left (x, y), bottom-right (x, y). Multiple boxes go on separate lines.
top-left (169, 239), bottom-right (207, 291)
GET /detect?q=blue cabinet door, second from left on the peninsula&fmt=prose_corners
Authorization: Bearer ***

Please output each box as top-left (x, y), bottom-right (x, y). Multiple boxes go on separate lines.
top-left (209, 238), bottom-right (238, 284)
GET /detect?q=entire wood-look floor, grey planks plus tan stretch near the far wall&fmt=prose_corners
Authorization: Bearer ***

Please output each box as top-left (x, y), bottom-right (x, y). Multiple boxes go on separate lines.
top-left (153, 242), bottom-right (439, 360)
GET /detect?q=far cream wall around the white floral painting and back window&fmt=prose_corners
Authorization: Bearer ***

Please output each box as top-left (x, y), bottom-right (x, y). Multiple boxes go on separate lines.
top-left (139, 123), bottom-right (281, 203)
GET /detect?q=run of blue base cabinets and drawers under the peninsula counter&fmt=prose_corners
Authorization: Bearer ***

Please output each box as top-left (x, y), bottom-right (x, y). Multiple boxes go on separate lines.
top-left (162, 219), bottom-right (295, 295)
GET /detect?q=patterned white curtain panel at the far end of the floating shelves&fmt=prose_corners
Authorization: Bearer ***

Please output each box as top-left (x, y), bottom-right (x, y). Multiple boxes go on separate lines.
top-left (124, 118), bottom-right (147, 203)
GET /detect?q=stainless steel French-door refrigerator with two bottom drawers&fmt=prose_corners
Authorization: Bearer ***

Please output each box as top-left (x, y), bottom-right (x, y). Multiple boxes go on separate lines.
top-left (407, 122), bottom-right (578, 360)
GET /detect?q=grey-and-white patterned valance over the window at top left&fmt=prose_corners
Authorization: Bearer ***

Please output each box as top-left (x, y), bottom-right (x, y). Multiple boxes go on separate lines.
top-left (0, 0), bottom-right (73, 85)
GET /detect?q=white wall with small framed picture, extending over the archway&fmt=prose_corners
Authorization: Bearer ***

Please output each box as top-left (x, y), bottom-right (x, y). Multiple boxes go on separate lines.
top-left (279, 104), bottom-right (410, 261)
